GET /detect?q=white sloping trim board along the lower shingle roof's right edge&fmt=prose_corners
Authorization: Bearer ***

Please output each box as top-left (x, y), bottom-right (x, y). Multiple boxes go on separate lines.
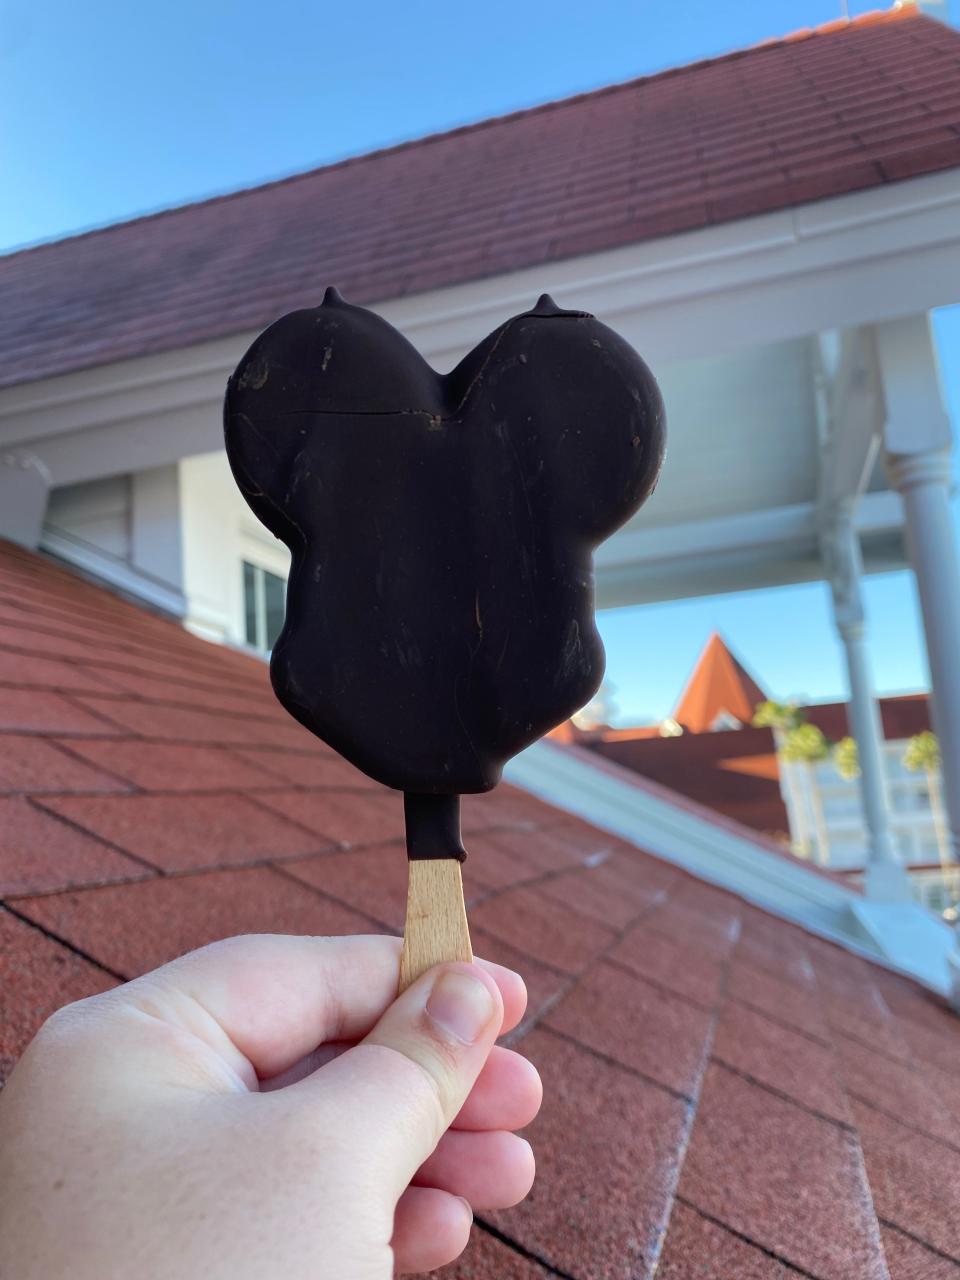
top-left (504, 740), bottom-right (960, 996)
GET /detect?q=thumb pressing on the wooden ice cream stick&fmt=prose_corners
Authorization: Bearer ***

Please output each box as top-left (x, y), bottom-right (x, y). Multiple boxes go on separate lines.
top-left (294, 964), bottom-right (503, 1196)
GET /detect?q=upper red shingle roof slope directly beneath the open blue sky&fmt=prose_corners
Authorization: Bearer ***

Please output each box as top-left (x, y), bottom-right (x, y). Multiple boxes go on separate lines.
top-left (0, 6), bottom-right (960, 385)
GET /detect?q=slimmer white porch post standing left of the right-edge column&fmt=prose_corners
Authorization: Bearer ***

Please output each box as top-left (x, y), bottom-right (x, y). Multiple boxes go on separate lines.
top-left (823, 499), bottom-right (910, 902)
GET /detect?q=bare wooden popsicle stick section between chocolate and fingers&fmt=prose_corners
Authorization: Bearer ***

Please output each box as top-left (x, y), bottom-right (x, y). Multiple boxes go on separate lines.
top-left (399, 858), bottom-right (474, 992)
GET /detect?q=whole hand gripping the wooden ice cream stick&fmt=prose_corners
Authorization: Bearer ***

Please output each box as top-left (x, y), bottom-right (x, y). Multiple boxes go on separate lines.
top-left (0, 936), bottom-right (540, 1280)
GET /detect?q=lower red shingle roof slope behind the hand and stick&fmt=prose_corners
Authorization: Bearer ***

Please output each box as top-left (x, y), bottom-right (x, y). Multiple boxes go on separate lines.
top-left (0, 544), bottom-right (960, 1280)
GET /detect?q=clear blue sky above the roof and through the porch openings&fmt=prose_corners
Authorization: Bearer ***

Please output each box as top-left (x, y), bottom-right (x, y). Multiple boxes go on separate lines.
top-left (0, 0), bottom-right (960, 719)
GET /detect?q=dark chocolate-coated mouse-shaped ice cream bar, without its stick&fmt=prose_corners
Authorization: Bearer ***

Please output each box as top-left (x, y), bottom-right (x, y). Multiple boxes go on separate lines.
top-left (224, 289), bottom-right (664, 794)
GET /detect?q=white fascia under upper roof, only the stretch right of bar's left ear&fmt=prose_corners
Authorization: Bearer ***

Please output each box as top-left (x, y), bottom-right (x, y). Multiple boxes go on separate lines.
top-left (379, 169), bottom-right (960, 361)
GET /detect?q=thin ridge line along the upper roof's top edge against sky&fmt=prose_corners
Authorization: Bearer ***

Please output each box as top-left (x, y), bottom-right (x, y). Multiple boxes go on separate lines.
top-left (0, 0), bottom-right (934, 261)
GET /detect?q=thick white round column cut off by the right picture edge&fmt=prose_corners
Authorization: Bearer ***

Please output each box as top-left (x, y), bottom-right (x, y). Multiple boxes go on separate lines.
top-left (887, 449), bottom-right (960, 861)
